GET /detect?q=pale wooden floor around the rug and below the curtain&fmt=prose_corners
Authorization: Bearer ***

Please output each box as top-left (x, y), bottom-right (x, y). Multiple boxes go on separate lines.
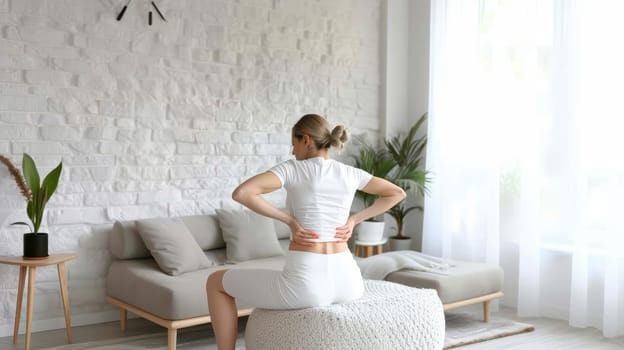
top-left (0, 309), bottom-right (624, 350)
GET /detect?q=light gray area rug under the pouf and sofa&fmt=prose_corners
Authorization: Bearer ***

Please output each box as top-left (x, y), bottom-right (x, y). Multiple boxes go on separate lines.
top-left (43, 313), bottom-right (533, 350)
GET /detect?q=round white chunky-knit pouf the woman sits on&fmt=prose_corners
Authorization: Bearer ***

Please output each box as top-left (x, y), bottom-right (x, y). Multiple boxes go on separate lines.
top-left (245, 280), bottom-right (444, 350)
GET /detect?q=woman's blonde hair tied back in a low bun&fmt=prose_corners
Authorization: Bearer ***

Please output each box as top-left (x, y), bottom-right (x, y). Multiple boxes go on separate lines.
top-left (292, 114), bottom-right (349, 150)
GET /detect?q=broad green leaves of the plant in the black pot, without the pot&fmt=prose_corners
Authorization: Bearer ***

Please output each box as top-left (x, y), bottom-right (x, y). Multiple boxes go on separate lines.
top-left (0, 153), bottom-right (63, 234)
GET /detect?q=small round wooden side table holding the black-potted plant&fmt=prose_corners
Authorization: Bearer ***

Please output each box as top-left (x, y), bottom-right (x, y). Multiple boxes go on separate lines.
top-left (0, 254), bottom-right (78, 350)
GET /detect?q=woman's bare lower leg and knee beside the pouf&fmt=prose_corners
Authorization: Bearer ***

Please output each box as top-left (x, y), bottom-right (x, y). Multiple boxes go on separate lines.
top-left (206, 270), bottom-right (238, 350)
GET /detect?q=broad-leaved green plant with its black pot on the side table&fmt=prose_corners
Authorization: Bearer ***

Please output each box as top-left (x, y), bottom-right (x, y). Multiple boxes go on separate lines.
top-left (0, 153), bottom-right (63, 259)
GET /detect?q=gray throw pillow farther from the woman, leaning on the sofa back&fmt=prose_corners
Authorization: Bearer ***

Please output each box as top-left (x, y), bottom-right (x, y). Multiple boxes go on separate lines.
top-left (136, 218), bottom-right (214, 276)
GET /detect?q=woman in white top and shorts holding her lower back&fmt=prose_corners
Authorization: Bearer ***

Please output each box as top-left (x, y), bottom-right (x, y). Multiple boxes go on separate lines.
top-left (206, 114), bottom-right (405, 350)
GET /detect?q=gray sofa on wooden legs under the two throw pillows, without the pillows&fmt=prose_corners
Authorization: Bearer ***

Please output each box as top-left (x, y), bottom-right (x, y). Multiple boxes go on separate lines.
top-left (106, 214), bottom-right (289, 350)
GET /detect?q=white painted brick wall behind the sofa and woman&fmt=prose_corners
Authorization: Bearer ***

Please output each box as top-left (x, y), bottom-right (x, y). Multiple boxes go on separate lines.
top-left (0, 0), bottom-right (381, 336)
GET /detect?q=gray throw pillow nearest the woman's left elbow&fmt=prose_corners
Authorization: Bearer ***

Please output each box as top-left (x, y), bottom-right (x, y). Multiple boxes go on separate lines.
top-left (216, 209), bottom-right (284, 261)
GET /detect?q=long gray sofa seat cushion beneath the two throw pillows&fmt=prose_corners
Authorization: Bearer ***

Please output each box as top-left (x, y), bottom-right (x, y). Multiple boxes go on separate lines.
top-left (106, 249), bottom-right (285, 320)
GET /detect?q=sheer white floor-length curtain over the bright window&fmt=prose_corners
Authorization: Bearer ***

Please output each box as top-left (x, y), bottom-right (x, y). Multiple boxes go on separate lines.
top-left (423, 0), bottom-right (624, 337)
